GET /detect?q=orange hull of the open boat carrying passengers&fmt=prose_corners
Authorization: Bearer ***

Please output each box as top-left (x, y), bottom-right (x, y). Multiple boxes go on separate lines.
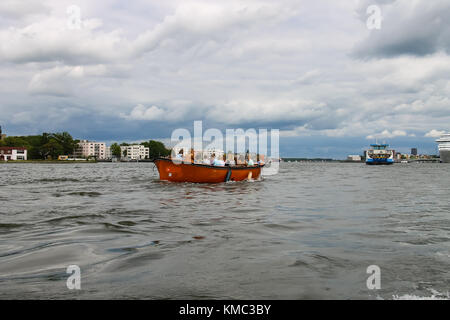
top-left (154, 158), bottom-right (264, 183)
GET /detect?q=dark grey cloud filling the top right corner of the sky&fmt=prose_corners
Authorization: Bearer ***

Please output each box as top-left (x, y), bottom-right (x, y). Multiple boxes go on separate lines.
top-left (353, 0), bottom-right (450, 58)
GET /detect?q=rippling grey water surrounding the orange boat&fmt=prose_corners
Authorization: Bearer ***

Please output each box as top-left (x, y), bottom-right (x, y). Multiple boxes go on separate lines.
top-left (0, 163), bottom-right (450, 299)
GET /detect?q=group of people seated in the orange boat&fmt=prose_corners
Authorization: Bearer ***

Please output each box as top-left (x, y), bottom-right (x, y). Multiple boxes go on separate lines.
top-left (175, 149), bottom-right (264, 167)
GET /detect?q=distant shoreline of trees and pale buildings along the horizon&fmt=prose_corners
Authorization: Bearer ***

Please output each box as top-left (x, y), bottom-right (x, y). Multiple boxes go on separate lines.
top-left (0, 126), bottom-right (450, 162)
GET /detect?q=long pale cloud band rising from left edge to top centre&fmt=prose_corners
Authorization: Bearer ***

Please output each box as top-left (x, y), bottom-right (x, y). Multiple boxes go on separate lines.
top-left (0, 1), bottom-right (292, 65)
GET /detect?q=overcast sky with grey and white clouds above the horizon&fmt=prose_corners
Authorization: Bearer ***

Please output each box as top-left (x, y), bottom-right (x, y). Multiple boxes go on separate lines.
top-left (0, 0), bottom-right (450, 158)
